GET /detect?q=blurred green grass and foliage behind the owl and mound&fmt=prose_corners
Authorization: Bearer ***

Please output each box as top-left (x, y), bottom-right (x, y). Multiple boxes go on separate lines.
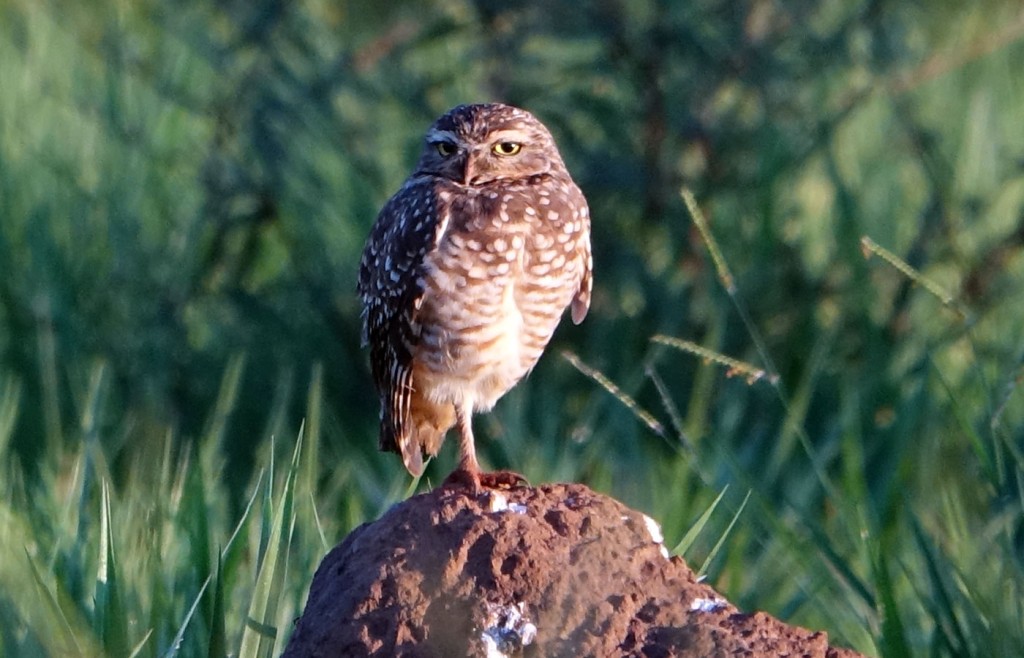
top-left (0, 0), bottom-right (1024, 656)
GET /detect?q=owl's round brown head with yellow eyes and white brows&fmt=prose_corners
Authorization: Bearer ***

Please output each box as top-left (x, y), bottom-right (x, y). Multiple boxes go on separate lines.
top-left (417, 103), bottom-right (565, 187)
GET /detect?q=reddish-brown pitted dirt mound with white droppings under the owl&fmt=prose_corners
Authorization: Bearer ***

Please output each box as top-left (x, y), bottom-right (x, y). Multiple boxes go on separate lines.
top-left (285, 484), bottom-right (859, 658)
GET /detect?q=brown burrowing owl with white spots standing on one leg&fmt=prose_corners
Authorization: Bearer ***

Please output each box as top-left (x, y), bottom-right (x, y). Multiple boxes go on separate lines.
top-left (358, 104), bottom-right (592, 491)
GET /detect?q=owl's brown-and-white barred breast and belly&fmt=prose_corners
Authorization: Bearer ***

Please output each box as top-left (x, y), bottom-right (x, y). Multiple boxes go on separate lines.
top-left (413, 183), bottom-right (586, 411)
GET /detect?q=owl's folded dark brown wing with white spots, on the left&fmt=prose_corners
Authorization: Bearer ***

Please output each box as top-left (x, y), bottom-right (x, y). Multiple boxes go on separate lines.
top-left (356, 178), bottom-right (447, 473)
